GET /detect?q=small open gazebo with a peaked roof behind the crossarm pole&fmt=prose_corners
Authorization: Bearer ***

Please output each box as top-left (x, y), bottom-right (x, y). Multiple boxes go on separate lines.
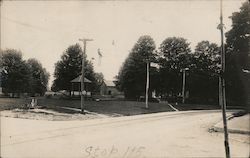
top-left (70, 75), bottom-right (92, 96)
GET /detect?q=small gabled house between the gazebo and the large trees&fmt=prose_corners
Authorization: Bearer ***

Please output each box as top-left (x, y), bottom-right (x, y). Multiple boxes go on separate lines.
top-left (100, 80), bottom-right (121, 95)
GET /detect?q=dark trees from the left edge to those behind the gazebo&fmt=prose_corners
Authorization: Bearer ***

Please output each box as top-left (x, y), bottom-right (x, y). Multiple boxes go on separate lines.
top-left (0, 44), bottom-right (104, 97)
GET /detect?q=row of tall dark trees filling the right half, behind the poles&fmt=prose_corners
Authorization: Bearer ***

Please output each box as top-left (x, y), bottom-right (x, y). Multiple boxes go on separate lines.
top-left (117, 2), bottom-right (250, 105)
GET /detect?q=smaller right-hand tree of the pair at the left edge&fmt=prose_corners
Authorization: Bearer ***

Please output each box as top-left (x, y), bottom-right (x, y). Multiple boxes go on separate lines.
top-left (27, 58), bottom-right (49, 95)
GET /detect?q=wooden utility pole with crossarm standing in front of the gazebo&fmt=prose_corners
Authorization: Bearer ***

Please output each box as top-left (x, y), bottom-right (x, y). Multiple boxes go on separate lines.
top-left (79, 38), bottom-right (93, 114)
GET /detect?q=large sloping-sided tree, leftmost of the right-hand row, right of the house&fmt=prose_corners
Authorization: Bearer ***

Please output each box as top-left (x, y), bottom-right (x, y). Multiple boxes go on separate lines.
top-left (117, 35), bottom-right (156, 99)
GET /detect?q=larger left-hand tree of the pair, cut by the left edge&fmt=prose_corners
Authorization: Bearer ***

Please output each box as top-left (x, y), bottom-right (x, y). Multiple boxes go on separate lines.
top-left (1, 49), bottom-right (31, 96)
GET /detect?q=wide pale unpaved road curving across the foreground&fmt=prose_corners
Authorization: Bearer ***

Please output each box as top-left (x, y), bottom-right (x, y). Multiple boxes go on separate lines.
top-left (1, 111), bottom-right (249, 158)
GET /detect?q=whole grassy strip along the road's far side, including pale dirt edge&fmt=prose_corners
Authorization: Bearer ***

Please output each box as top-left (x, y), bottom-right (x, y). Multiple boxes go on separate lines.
top-left (0, 97), bottom-right (245, 121)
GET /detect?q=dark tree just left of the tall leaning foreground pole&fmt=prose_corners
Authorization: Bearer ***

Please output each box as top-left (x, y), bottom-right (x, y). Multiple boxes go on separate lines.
top-left (187, 41), bottom-right (220, 103)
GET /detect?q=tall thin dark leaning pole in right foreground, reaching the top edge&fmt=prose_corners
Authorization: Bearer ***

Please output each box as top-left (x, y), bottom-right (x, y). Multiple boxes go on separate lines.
top-left (218, 0), bottom-right (230, 158)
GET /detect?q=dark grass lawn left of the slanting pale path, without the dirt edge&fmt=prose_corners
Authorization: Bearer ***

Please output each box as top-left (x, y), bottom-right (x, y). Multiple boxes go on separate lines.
top-left (0, 97), bottom-right (174, 116)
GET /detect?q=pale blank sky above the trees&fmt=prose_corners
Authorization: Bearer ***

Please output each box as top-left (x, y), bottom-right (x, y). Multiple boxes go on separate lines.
top-left (0, 0), bottom-right (244, 85)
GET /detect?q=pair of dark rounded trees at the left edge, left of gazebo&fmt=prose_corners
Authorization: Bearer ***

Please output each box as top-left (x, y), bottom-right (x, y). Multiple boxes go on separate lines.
top-left (0, 49), bottom-right (50, 97)
